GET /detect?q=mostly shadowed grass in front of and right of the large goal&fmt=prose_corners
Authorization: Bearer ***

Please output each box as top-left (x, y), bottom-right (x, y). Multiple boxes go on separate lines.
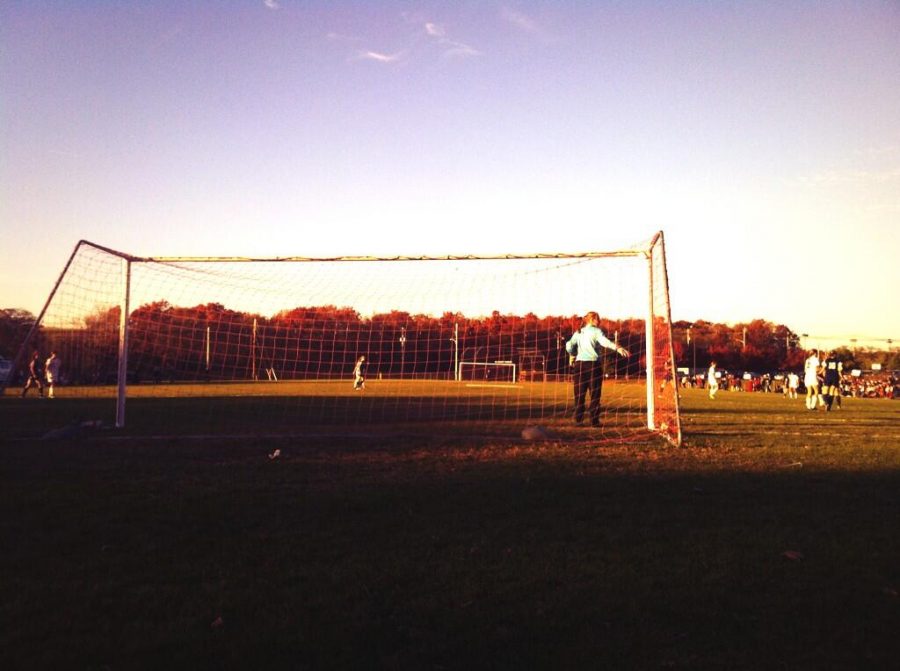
top-left (0, 393), bottom-right (900, 669)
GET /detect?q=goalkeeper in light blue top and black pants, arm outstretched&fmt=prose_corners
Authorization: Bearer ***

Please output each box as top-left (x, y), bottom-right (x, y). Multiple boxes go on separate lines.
top-left (566, 312), bottom-right (628, 426)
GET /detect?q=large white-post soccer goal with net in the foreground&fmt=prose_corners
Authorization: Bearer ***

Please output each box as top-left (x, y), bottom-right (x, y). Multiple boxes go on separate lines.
top-left (5, 232), bottom-right (681, 444)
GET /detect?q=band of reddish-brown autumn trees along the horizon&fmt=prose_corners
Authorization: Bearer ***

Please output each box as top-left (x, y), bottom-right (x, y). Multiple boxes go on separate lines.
top-left (0, 301), bottom-right (900, 383)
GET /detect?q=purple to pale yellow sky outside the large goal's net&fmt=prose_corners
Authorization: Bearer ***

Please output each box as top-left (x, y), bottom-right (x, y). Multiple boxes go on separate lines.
top-left (0, 0), bottom-right (900, 340)
